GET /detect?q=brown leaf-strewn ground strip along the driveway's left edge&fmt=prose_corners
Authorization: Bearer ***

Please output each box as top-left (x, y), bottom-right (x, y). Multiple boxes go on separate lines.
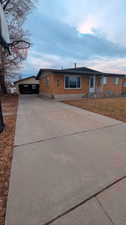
top-left (0, 96), bottom-right (18, 225)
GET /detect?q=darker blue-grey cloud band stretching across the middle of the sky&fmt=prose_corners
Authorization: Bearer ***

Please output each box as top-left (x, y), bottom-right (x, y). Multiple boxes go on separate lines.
top-left (25, 11), bottom-right (126, 60)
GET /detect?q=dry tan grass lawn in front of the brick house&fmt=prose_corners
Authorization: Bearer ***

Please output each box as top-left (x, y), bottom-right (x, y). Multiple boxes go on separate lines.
top-left (64, 97), bottom-right (126, 122)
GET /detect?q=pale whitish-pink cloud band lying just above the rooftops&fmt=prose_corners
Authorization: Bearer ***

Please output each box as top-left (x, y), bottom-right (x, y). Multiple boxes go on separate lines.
top-left (22, 47), bottom-right (126, 75)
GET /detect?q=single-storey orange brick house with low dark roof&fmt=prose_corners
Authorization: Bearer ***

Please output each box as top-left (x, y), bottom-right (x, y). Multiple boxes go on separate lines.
top-left (37, 67), bottom-right (126, 99)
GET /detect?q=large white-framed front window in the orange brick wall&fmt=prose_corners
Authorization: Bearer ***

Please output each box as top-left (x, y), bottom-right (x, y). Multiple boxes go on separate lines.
top-left (65, 76), bottom-right (81, 89)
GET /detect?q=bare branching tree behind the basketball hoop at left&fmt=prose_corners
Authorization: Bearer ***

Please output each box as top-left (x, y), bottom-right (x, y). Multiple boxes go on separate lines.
top-left (0, 0), bottom-right (34, 93)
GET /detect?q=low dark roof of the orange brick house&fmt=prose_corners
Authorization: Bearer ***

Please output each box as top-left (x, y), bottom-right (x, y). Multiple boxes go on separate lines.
top-left (36, 67), bottom-right (126, 80)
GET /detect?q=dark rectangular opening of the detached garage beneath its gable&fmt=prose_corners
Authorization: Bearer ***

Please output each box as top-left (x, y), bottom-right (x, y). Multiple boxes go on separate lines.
top-left (19, 84), bottom-right (39, 95)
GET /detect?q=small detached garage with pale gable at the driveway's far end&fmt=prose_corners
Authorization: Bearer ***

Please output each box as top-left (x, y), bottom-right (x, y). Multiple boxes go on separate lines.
top-left (14, 76), bottom-right (39, 94)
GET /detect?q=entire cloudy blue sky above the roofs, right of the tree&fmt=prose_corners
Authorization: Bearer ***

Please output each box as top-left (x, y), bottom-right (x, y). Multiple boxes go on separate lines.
top-left (20, 0), bottom-right (126, 76)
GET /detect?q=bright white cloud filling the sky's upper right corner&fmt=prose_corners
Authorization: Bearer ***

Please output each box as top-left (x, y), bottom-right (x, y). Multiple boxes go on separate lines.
top-left (67, 0), bottom-right (126, 47)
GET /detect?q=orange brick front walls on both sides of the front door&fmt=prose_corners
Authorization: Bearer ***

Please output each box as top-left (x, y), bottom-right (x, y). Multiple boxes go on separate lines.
top-left (39, 72), bottom-right (126, 98)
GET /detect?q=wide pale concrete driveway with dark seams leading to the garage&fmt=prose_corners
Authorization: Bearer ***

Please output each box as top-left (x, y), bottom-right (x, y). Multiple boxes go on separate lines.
top-left (6, 96), bottom-right (126, 225)
